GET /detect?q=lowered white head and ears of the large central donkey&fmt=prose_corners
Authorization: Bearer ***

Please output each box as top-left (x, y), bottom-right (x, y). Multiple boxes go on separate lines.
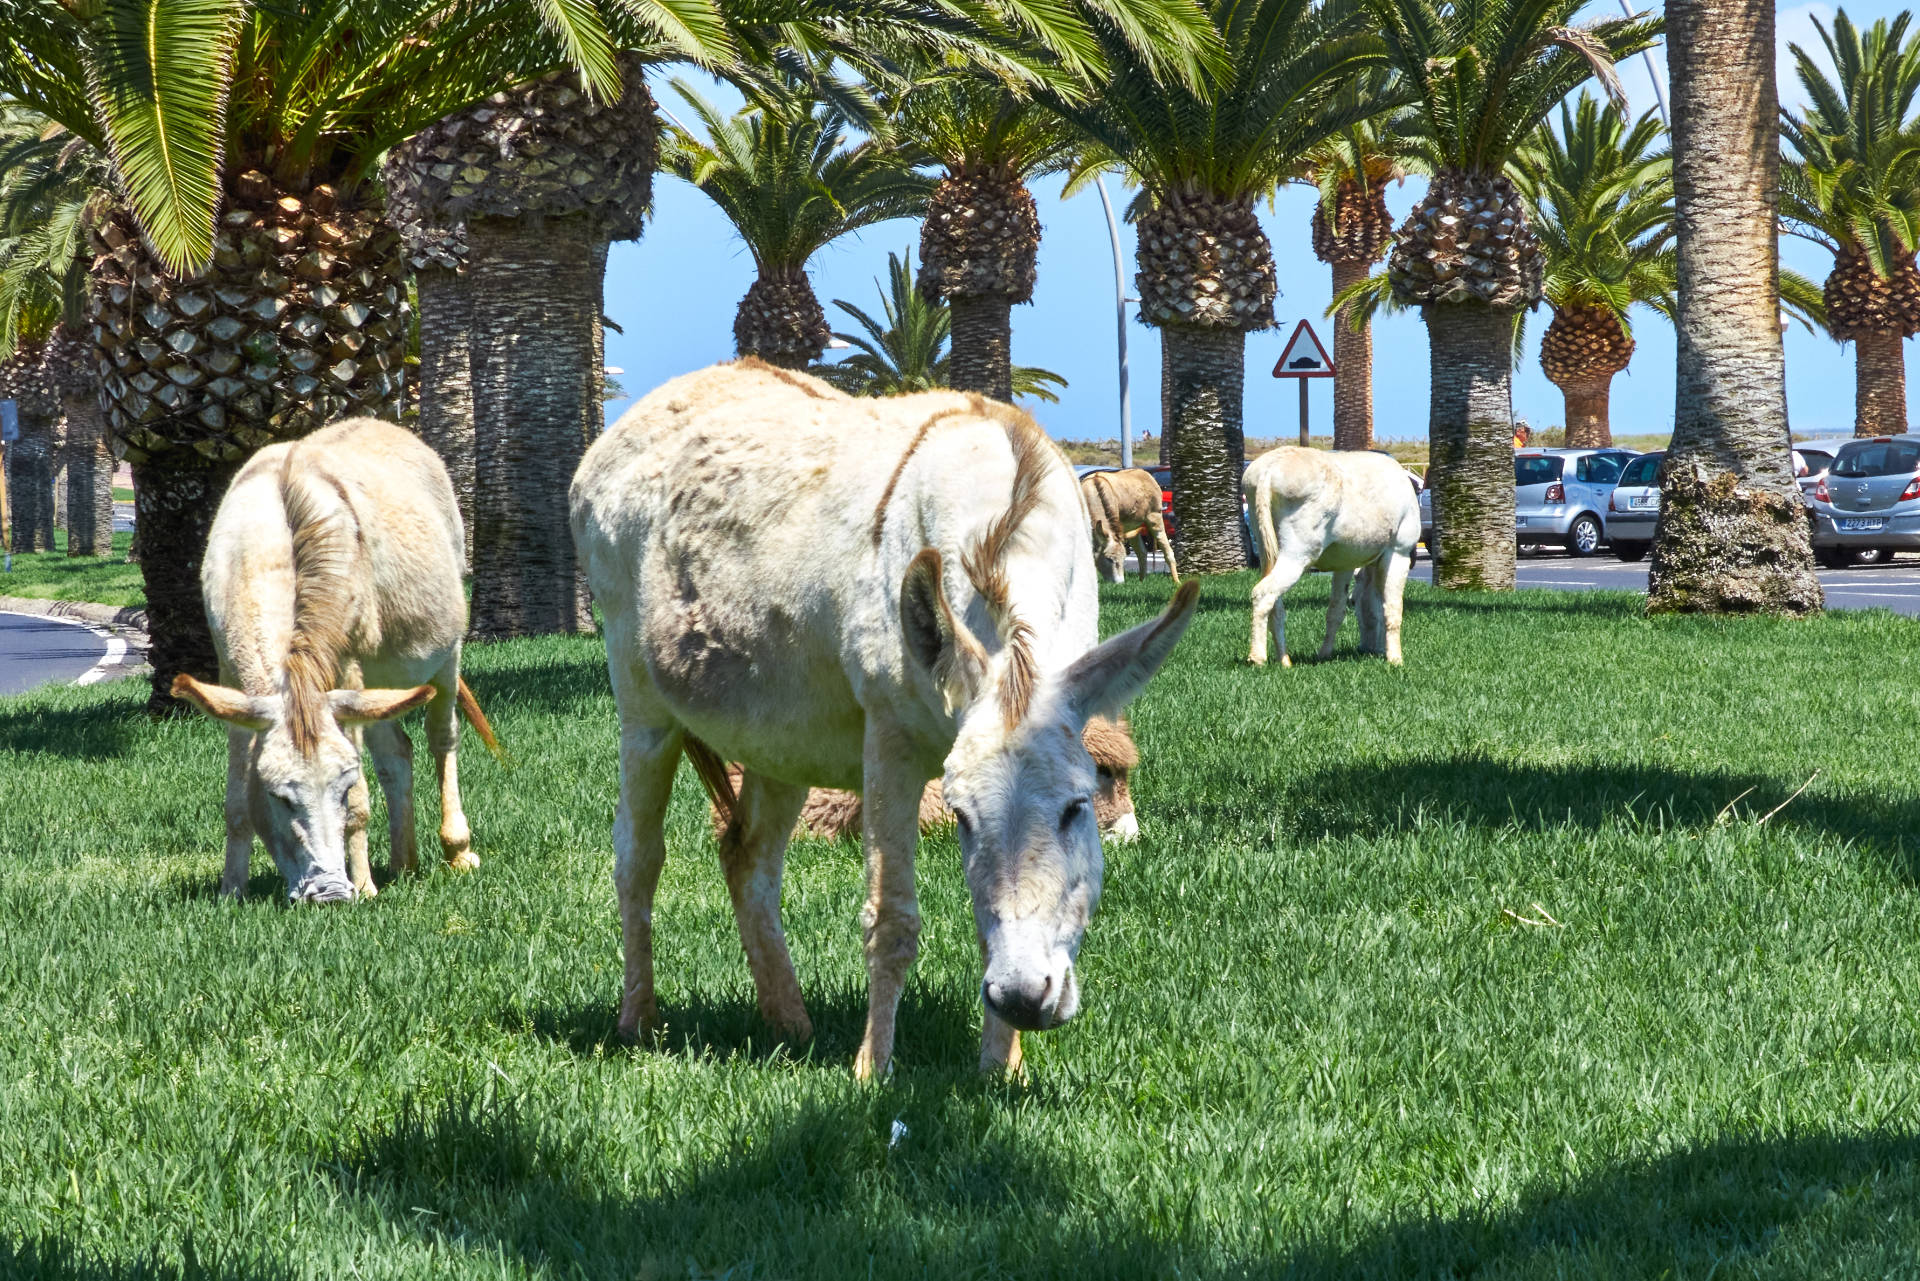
top-left (900, 549), bottom-right (1198, 1031)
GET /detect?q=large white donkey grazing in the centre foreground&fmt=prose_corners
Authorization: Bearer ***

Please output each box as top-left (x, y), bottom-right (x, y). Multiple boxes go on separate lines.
top-left (572, 359), bottom-right (1196, 1079)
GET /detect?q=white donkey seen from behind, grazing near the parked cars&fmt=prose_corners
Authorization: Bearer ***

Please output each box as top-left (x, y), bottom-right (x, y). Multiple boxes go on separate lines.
top-left (1240, 446), bottom-right (1421, 666)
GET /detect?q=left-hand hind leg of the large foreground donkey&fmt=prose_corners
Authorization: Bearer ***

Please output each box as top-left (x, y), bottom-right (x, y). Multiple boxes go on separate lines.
top-left (612, 724), bottom-right (680, 1041)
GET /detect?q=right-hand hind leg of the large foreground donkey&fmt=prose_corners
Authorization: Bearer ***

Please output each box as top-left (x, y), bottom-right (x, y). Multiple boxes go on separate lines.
top-left (720, 770), bottom-right (814, 1043)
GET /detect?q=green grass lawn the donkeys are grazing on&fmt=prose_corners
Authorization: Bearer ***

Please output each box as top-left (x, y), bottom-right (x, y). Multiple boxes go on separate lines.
top-left (0, 576), bottom-right (1920, 1281)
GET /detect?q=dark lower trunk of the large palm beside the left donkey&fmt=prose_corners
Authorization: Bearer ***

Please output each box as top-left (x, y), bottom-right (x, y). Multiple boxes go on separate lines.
top-left (132, 460), bottom-right (240, 716)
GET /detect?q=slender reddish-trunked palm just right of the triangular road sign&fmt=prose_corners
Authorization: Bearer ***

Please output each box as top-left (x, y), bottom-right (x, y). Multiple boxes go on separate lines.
top-left (1306, 84), bottom-right (1407, 449)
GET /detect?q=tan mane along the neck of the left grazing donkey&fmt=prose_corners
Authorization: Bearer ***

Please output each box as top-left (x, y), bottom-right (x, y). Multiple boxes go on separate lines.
top-left (280, 446), bottom-right (359, 755)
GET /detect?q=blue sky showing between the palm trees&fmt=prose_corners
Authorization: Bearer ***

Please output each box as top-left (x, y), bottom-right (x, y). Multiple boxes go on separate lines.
top-left (607, 0), bottom-right (1896, 440)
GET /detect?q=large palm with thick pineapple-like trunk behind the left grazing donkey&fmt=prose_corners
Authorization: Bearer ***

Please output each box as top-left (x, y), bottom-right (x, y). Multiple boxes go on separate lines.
top-left (0, 0), bottom-right (639, 713)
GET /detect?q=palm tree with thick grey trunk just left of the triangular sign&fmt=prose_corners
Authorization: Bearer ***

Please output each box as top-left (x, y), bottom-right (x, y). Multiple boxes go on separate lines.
top-left (1048, 0), bottom-right (1394, 572)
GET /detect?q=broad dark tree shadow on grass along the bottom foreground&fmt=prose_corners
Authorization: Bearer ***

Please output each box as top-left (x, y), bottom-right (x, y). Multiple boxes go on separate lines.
top-left (326, 1074), bottom-right (1920, 1281)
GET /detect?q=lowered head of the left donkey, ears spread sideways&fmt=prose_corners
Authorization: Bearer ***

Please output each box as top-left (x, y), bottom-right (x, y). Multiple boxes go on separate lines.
top-left (173, 674), bottom-right (434, 903)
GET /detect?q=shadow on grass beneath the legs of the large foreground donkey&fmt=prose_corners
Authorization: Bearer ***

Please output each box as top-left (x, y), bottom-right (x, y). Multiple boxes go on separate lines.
top-left (499, 979), bottom-right (979, 1072)
